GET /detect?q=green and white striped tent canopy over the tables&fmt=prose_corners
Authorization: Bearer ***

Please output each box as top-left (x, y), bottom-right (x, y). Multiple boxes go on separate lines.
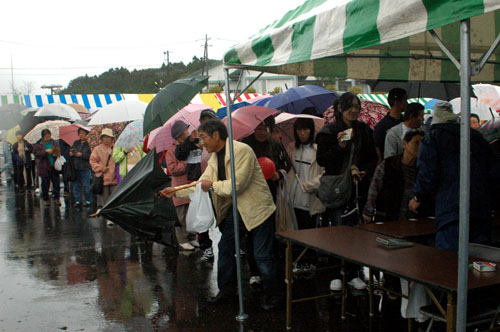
top-left (224, 0), bottom-right (500, 82)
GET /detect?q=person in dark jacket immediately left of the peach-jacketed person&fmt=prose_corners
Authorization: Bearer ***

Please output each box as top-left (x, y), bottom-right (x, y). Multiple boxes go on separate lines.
top-left (69, 128), bottom-right (92, 208)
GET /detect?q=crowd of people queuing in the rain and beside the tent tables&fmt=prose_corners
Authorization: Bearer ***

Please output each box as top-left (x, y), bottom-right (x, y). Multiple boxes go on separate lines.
top-left (0, 88), bottom-right (500, 310)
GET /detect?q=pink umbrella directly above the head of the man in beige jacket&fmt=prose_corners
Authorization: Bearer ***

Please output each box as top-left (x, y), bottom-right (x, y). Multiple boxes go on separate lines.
top-left (222, 106), bottom-right (279, 140)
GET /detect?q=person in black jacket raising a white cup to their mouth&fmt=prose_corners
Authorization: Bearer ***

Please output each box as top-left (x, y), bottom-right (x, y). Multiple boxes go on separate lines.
top-left (316, 92), bottom-right (377, 225)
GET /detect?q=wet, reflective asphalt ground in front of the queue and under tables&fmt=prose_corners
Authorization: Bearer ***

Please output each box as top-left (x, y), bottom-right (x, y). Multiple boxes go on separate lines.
top-left (0, 185), bottom-right (414, 332)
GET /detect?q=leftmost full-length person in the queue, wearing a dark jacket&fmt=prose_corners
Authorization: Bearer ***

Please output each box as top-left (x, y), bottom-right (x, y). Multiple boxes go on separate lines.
top-left (12, 131), bottom-right (33, 193)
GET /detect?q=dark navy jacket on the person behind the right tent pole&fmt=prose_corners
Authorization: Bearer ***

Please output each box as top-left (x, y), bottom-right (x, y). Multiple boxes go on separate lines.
top-left (414, 123), bottom-right (500, 230)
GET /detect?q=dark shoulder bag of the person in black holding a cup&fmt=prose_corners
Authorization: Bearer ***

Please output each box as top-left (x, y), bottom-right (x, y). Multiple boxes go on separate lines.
top-left (317, 143), bottom-right (355, 209)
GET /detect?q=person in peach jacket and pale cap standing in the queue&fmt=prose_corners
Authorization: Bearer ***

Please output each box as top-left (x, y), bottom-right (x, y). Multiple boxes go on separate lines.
top-left (90, 128), bottom-right (118, 226)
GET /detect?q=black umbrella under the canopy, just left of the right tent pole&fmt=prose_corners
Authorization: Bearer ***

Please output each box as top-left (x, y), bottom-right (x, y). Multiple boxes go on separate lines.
top-left (369, 81), bottom-right (460, 100)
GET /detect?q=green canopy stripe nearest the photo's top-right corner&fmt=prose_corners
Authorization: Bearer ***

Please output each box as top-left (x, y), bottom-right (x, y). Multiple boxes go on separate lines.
top-left (422, 0), bottom-right (484, 30)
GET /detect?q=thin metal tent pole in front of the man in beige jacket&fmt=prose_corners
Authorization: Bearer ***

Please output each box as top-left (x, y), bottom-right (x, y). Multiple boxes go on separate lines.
top-left (225, 68), bottom-right (248, 322)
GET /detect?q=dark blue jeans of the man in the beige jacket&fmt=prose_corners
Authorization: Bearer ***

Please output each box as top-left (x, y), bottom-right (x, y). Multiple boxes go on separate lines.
top-left (217, 208), bottom-right (285, 297)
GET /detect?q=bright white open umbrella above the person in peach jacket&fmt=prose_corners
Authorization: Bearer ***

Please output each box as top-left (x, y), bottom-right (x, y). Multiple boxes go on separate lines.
top-left (89, 100), bottom-right (148, 126)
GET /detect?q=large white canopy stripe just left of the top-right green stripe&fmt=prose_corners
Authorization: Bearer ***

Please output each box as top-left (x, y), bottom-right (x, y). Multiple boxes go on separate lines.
top-left (377, 0), bottom-right (427, 44)
